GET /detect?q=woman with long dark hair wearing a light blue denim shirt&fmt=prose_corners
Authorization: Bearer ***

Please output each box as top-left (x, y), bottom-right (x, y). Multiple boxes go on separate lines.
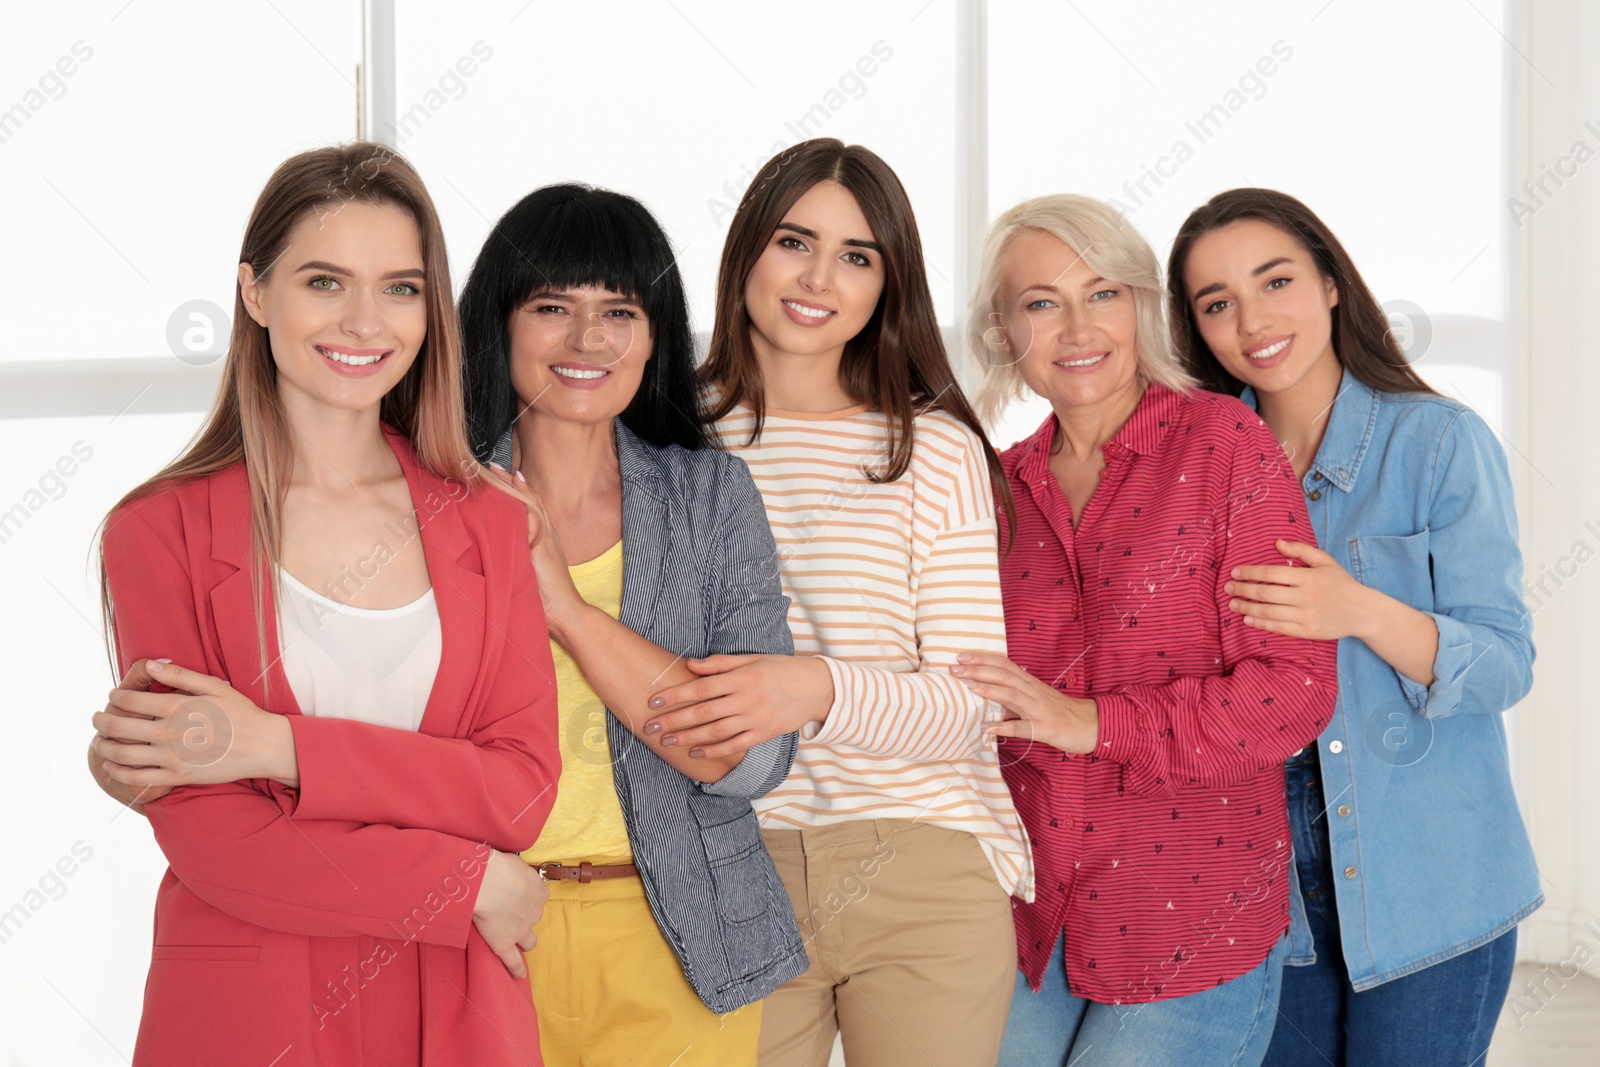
top-left (1168, 189), bottom-right (1544, 1067)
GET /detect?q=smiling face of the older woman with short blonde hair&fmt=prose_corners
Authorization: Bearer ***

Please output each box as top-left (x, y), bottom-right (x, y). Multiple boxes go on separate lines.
top-left (995, 229), bottom-right (1144, 421)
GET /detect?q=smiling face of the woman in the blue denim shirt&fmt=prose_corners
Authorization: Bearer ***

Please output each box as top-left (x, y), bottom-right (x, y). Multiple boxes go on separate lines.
top-left (1184, 219), bottom-right (1339, 394)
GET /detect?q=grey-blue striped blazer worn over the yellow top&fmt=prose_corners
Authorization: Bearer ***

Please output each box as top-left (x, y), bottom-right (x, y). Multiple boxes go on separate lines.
top-left (491, 419), bottom-right (810, 1014)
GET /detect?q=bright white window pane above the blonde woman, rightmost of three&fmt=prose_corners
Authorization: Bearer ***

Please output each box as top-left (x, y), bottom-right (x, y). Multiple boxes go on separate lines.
top-left (989, 0), bottom-right (1522, 342)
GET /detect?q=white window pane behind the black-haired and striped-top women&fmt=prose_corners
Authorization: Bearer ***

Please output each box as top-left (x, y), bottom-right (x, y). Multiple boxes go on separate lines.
top-left (395, 0), bottom-right (955, 331)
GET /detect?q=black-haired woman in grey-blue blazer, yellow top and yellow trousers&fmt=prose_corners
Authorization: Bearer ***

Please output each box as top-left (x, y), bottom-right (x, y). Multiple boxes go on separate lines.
top-left (461, 186), bottom-right (806, 1067)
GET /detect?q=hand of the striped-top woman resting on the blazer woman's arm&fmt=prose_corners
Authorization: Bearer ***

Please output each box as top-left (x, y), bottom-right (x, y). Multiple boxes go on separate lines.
top-left (645, 654), bottom-right (834, 758)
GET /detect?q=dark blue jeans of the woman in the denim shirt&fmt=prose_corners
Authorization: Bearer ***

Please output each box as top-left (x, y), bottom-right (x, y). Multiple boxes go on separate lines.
top-left (1264, 749), bottom-right (1517, 1067)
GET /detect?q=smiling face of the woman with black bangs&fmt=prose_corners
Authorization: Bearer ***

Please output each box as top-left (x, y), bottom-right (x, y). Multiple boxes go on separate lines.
top-left (509, 285), bottom-right (654, 424)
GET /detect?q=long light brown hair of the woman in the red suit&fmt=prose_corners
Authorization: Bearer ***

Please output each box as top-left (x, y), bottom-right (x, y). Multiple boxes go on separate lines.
top-left (99, 142), bottom-right (499, 685)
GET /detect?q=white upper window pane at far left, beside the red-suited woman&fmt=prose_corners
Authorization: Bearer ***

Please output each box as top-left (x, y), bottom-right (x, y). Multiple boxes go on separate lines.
top-left (0, 0), bottom-right (360, 362)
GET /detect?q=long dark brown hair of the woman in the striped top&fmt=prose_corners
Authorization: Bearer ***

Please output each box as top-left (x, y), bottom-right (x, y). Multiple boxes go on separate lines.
top-left (701, 138), bottom-right (1013, 531)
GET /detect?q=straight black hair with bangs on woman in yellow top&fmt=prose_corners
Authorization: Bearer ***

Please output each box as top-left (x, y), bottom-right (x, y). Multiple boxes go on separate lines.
top-left (459, 184), bottom-right (707, 462)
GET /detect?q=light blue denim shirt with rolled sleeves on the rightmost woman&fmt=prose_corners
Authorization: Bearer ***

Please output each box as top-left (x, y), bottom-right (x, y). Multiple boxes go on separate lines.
top-left (1240, 370), bottom-right (1544, 992)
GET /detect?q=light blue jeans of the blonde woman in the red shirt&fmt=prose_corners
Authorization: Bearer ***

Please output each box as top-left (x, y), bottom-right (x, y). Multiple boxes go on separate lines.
top-left (998, 934), bottom-right (1288, 1067)
